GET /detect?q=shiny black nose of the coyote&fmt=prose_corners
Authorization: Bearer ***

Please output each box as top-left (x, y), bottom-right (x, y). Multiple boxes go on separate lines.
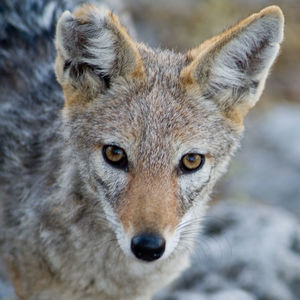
top-left (131, 233), bottom-right (166, 261)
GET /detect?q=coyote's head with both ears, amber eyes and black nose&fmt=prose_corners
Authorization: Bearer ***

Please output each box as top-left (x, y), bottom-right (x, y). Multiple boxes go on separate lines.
top-left (55, 5), bottom-right (283, 261)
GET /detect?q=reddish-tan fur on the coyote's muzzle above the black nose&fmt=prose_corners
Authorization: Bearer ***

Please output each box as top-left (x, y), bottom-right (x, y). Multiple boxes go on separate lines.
top-left (118, 175), bottom-right (181, 234)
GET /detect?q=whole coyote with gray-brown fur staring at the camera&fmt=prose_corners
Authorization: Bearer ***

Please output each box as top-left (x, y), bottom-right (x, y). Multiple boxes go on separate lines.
top-left (0, 1), bottom-right (284, 300)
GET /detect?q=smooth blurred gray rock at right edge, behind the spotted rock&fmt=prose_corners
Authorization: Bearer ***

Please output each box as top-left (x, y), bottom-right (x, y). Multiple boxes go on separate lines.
top-left (220, 104), bottom-right (300, 216)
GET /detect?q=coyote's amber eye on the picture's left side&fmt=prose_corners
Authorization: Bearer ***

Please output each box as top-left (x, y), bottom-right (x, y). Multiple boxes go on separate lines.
top-left (102, 145), bottom-right (128, 171)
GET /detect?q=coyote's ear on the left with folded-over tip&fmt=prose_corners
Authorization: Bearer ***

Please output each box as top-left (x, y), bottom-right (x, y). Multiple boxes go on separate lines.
top-left (55, 5), bottom-right (144, 105)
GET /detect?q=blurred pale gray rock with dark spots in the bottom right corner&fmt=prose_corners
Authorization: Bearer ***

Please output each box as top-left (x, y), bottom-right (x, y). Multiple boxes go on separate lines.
top-left (156, 201), bottom-right (300, 300)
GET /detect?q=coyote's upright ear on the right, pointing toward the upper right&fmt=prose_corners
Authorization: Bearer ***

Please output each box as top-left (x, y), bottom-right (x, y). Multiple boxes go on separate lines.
top-left (181, 6), bottom-right (284, 123)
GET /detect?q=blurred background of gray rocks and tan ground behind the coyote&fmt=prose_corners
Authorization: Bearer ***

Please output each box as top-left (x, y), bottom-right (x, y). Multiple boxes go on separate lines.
top-left (0, 0), bottom-right (300, 300)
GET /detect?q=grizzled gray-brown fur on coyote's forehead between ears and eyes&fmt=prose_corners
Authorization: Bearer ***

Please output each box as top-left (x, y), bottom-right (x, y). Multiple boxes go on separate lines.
top-left (67, 45), bottom-right (240, 161)
